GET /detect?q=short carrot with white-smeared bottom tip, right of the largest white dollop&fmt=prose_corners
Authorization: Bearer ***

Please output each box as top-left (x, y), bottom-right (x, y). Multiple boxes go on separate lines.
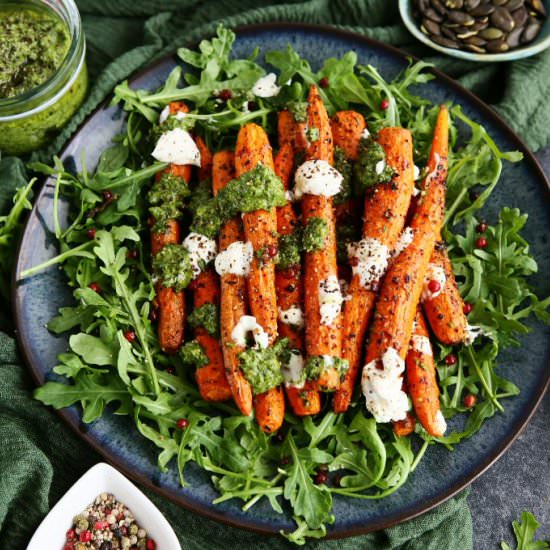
top-left (405, 308), bottom-right (445, 437)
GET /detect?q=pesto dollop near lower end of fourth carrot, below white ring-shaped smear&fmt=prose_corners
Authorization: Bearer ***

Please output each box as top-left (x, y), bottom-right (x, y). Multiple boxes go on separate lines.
top-left (239, 338), bottom-right (289, 395)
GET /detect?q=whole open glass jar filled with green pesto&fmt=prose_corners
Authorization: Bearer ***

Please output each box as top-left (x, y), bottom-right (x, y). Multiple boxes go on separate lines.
top-left (0, 0), bottom-right (88, 154)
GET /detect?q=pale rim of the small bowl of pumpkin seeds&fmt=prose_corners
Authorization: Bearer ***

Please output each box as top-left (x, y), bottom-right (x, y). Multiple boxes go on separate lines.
top-left (399, 0), bottom-right (550, 63)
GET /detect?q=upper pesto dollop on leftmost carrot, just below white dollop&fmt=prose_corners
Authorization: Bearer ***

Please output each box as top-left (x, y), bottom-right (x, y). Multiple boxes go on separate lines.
top-left (147, 172), bottom-right (191, 233)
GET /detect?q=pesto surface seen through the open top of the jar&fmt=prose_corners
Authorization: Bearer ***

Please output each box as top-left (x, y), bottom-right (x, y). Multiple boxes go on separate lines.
top-left (0, 4), bottom-right (71, 98)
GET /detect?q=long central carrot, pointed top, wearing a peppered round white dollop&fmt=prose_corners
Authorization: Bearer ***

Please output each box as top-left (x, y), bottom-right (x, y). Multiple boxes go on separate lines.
top-left (301, 86), bottom-right (342, 391)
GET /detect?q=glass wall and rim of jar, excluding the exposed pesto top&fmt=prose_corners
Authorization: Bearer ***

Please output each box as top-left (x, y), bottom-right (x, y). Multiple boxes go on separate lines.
top-left (0, 0), bottom-right (88, 154)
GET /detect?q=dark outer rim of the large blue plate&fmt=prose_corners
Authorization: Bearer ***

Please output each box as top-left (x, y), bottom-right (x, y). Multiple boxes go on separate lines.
top-left (12, 22), bottom-right (550, 539)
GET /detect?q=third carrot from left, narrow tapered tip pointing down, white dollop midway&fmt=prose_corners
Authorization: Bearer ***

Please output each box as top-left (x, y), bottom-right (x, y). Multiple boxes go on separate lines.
top-left (212, 151), bottom-right (252, 416)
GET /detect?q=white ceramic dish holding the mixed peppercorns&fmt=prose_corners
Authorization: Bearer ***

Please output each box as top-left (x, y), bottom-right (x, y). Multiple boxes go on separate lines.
top-left (27, 462), bottom-right (181, 550)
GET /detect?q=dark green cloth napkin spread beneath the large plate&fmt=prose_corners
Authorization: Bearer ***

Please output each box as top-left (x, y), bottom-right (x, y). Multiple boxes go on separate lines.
top-left (6, 0), bottom-right (550, 550)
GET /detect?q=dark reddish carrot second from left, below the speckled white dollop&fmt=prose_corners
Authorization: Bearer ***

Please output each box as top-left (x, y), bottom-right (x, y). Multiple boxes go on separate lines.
top-left (193, 269), bottom-right (232, 401)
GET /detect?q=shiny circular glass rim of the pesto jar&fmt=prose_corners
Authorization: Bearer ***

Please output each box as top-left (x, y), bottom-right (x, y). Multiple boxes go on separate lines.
top-left (0, 0), bottom-right (86, 121)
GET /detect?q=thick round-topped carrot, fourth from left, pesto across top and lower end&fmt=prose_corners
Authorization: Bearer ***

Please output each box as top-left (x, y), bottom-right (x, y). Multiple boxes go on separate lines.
top-left (235, 124), bottom-right (285, 433)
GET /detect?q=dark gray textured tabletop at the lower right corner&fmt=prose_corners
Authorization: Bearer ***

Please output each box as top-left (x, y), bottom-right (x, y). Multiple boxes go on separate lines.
top-left (470, 147), bottom-right (550, 550)
